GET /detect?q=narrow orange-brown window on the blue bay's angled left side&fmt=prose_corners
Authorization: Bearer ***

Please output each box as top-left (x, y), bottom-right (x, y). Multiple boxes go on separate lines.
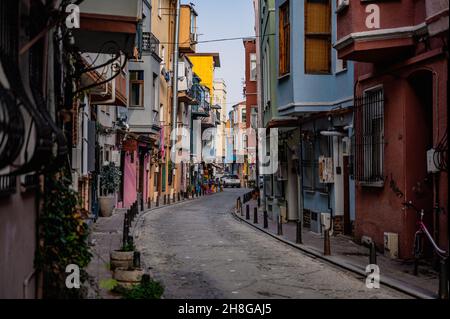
top-left (278, 1), bottom-right (291, 76)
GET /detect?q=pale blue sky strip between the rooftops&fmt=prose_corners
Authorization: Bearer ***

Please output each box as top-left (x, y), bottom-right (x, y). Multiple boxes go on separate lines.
top-left (189, 0), bottom-right (255, 111)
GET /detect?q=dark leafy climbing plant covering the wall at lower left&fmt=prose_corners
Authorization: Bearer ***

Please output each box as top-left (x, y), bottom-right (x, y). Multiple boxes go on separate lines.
top-left (36, 165), bottom-right (92, 299)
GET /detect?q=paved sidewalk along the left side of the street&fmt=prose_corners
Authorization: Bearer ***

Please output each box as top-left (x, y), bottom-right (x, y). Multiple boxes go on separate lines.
top-left (86, 194), bottom-right (221, 299)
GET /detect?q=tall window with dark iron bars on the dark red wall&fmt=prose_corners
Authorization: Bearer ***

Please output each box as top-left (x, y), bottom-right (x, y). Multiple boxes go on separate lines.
top-left (355, 88), bottom-right (384, 186)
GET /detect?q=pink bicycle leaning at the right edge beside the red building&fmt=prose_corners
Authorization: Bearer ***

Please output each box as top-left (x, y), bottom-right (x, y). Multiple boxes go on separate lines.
top-left (403, 201), bottom-right (448, 276)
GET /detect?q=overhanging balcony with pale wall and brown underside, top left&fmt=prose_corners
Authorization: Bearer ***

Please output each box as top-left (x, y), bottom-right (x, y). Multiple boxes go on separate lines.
top-left (73, 0), bottom-right (142, 57)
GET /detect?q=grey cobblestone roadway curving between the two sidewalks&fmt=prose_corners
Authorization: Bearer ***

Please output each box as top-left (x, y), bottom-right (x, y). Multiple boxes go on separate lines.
top-left (135, 190), bottom-right (408, 299)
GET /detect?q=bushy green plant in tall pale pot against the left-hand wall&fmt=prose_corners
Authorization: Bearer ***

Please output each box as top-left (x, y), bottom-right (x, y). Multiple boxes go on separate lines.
top-left (99, 163), bottom-right (122, 217)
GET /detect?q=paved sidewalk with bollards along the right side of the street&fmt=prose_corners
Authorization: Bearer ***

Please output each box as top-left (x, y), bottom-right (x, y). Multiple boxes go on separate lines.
top-left (233, 200), bottom-right (439, 299)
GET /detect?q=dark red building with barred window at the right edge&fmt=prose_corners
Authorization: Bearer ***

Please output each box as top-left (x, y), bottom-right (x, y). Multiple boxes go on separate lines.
top-left (335, 0), bottom-right (448, 258)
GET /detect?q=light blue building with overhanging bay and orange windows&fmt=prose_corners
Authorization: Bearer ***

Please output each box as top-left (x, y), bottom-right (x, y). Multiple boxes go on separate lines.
top-left (267, 0), bottom-right (354, 233)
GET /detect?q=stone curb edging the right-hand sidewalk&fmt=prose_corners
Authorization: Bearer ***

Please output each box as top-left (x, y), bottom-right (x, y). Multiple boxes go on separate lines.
top-left (231, 210), bottom-right (438, 299)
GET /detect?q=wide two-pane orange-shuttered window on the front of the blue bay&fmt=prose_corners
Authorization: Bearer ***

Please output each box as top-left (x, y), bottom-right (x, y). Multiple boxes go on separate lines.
top-left (305, 0), bottom-right (331, 74)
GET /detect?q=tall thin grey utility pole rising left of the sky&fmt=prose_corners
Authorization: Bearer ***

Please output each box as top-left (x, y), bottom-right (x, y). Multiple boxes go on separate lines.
top-left (170, 0), bottom-right (180, 165)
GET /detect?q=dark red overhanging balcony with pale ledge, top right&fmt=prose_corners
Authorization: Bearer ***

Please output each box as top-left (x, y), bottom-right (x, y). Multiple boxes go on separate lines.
top-left (334, 0), bottom-right (427, 63)
